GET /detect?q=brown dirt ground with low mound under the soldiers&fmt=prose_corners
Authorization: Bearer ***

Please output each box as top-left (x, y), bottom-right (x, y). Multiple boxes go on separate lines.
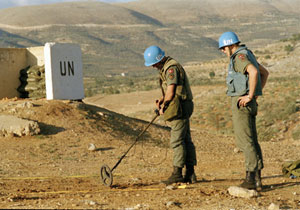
top-left (0, 83), bottom-right (300, 210)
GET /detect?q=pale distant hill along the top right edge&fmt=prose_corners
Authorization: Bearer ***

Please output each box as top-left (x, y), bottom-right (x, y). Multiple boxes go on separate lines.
top-left (125, 0), bottom-right (300, 24)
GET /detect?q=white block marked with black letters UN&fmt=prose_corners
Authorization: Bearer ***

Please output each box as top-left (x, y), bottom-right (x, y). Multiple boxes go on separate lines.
top-left (44, 43), bottom-right (84, 100)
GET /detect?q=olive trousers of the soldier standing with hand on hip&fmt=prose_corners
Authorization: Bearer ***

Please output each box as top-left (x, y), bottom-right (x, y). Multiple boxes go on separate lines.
top-left (231, 96), bottom-right (264, 172)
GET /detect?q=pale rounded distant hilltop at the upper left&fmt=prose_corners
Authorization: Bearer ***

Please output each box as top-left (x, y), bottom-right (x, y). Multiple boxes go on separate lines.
top-left (0, 2), bottom-right (162, 27)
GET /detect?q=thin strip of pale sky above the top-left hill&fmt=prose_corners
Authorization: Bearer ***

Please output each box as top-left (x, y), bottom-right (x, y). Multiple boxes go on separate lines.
top-left (0, 0), bottom-right (136, 9)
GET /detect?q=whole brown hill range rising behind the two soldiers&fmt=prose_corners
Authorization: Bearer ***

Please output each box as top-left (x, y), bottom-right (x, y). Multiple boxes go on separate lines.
top-left (0, 0), bottom-right (300, 77)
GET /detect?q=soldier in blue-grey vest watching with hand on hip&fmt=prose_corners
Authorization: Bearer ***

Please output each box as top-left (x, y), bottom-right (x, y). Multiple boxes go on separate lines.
top-left (219, 31), bottom-right (269, 190)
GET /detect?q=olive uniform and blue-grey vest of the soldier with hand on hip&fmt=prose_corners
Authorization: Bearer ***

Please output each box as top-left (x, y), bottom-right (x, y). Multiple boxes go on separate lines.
top-left (227, 46), bottom-right (264, 172)
